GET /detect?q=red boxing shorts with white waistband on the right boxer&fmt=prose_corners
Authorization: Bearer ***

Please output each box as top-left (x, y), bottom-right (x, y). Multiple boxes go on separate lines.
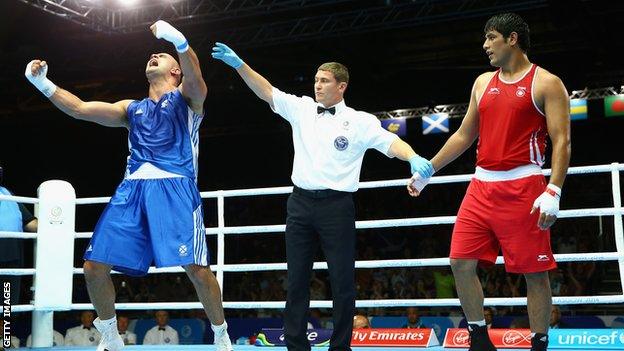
top-left (449, 170), bottom-right (557, 273)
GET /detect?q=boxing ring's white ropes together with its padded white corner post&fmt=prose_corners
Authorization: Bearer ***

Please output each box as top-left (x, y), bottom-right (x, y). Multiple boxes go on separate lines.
top-left (0, 163), bottom-right (624, 350)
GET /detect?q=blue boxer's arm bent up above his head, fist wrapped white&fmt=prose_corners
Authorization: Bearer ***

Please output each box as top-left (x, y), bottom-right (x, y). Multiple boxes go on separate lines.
top-left (150, 20), bottom-right (208, 114)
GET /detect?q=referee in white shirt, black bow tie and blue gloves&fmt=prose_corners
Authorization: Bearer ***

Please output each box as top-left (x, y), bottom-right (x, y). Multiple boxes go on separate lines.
top-left (212, 43), bottom-right (433, 351)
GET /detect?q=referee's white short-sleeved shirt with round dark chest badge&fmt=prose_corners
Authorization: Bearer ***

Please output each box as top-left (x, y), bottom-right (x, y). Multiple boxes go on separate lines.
top-left (273, 88), bottom-right (398, 192)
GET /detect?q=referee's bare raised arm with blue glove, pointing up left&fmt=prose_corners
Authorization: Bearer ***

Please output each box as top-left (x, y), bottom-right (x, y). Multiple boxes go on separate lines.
top-left (212, 43), bottom-right (274, 108)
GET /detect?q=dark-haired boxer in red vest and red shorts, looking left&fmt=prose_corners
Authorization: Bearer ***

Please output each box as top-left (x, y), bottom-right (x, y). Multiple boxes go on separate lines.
top-left (408, 13), bottom-right (570, 351)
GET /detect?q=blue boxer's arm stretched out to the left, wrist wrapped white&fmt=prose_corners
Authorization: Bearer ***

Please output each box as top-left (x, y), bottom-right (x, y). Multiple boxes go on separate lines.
top-left (24, 60), bottom-right (132, 127)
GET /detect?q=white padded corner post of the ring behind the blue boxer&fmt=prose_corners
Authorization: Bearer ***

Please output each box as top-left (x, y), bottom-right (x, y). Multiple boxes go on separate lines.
top-left (32, 180), bottom-right (76, 347)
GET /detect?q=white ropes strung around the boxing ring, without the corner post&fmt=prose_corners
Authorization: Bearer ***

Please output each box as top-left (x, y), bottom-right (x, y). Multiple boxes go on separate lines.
top-left (0, 164), bottom-right (624, 312)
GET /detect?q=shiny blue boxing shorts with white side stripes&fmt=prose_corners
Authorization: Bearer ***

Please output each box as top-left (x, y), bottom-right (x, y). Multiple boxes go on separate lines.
top-left (84, 177), bottom-right (209, 276)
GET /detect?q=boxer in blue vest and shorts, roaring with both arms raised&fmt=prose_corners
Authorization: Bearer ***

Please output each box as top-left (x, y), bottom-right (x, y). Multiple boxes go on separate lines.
top-left (25, 21), bottom-right (232, 351)
